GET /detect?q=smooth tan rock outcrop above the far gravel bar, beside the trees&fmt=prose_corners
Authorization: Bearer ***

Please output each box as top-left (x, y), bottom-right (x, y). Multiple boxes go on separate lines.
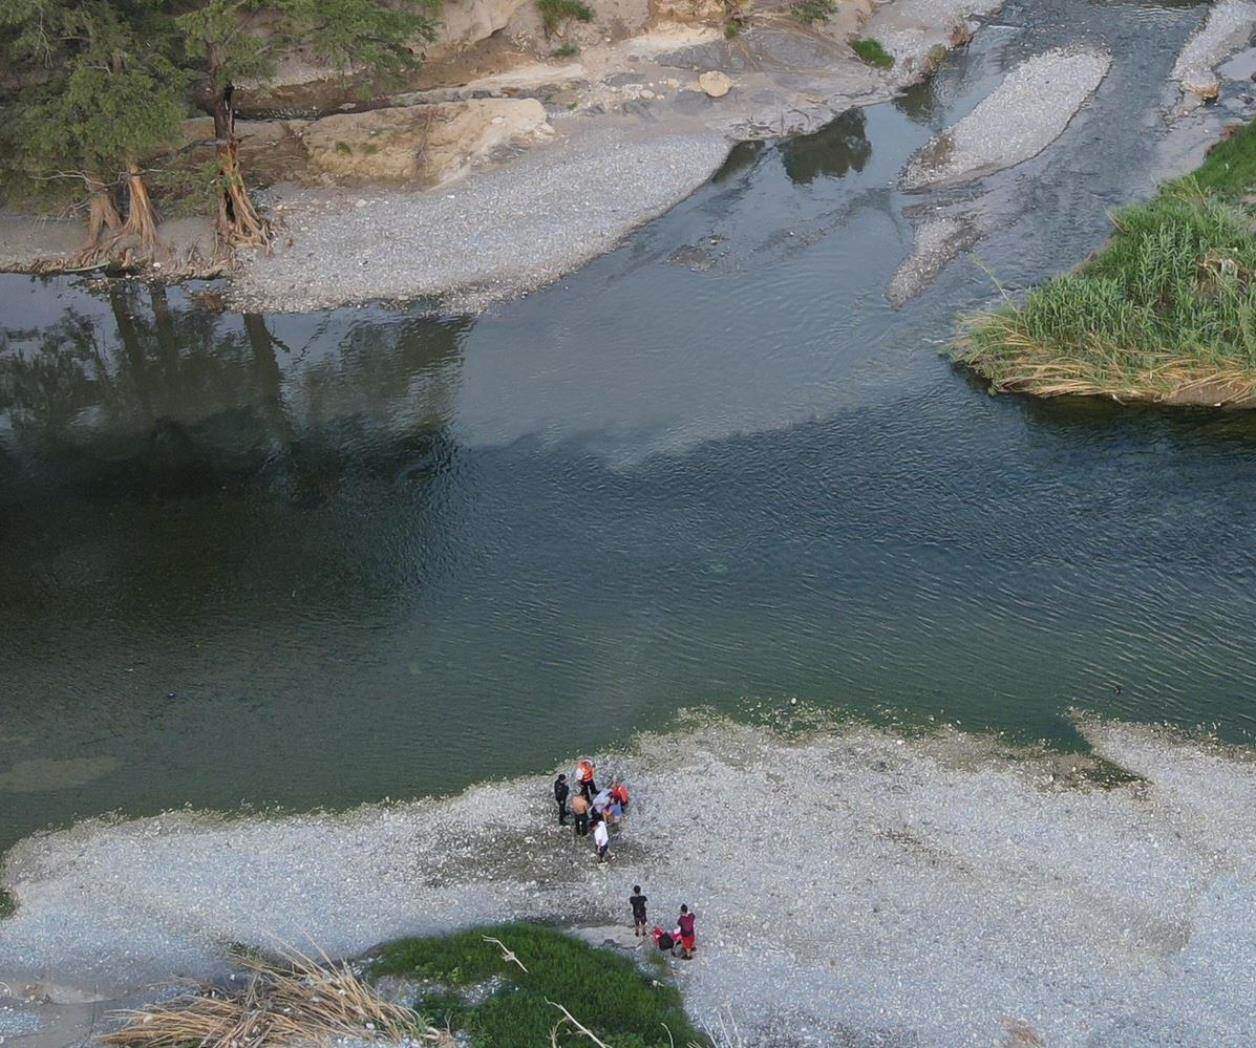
top-left (301, 98), bottom-right (554, 185)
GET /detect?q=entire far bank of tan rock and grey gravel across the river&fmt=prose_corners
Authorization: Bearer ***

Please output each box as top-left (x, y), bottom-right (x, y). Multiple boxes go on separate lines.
top-left (0, 0), bottom-right (999, 312)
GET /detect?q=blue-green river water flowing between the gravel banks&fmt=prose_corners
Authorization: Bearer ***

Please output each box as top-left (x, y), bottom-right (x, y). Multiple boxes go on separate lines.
top-left (0, 0), bottom-right (1256, 846)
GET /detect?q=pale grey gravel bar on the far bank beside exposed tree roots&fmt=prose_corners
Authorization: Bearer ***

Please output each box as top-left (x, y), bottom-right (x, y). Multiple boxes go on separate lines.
top-left (232, 127), bottom-right (731, 313)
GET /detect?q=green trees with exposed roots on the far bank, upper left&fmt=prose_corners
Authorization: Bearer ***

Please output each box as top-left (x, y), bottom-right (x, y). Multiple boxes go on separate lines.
top-left (0, 0), bottom-right (438, 266)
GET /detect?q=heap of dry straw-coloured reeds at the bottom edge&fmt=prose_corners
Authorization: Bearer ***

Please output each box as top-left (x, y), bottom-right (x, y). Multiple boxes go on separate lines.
top-left (103, 951), bottom-right (453, 1048)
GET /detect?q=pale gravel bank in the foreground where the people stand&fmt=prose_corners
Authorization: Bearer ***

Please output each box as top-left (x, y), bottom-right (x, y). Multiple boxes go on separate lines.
top-left (0, 724), bottom-right (1256, 1047)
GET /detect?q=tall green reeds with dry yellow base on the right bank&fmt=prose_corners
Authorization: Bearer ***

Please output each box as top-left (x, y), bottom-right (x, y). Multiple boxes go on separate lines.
top-left (955, 118), bottom-right (1256, 406)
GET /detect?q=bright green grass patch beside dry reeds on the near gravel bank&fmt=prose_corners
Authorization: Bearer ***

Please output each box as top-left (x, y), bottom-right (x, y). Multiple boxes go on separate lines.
top-left (369, 924), bottom-right (708, 1048)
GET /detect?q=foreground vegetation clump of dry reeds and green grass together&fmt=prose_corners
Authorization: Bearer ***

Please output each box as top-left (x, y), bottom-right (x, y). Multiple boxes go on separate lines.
top-left (103, 922), bottom-right (712, 1048)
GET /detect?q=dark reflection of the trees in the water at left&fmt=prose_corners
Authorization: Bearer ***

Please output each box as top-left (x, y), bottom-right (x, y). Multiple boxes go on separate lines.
top-left (0, 283), bottom-right (466, 501)
